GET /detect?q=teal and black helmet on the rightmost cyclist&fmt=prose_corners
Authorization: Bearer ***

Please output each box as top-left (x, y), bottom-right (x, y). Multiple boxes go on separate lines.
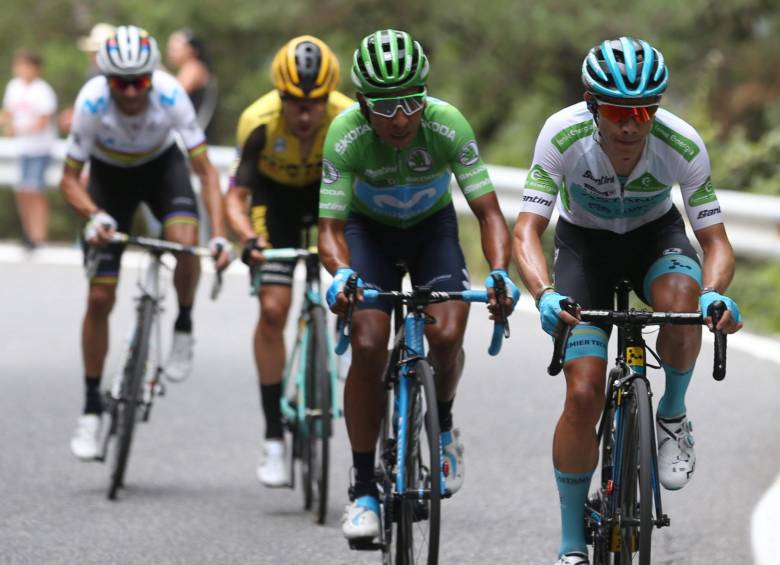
top-left (582, 37), bottom-right (669, 98)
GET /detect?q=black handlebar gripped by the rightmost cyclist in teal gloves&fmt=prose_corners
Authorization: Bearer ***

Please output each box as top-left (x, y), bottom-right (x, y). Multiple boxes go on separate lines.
top-left (547, 298), bottom-right (726, 381)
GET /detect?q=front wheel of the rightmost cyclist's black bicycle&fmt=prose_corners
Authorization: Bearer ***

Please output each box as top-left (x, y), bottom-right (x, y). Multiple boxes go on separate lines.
top-left (615, 378), bottom-right (654, 565)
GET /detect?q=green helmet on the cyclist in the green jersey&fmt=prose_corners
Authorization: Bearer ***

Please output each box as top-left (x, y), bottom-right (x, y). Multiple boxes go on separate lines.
top-left (350, 29), bottom-right (428, 93)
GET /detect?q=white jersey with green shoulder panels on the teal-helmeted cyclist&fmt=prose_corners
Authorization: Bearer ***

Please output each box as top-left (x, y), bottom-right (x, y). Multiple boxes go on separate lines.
top-left (521, 102), bottom-right (723, 234)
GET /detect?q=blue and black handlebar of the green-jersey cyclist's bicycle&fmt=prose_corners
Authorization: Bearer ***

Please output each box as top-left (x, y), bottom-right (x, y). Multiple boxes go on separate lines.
top-left (335, 284), bottom-right (508, 355)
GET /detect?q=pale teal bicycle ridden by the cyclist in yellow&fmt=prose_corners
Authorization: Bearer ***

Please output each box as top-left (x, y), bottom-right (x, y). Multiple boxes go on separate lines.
top-left (250, 240), bottom-right (341, 524)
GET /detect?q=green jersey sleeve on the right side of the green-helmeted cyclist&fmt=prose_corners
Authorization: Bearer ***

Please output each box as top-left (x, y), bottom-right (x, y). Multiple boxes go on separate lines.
top-left (450, 107), bottom-right (494, 201)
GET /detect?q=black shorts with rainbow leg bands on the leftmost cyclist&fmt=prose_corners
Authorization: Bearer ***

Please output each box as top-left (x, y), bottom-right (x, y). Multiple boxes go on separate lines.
top-left (84, 145), bottom-right (198, 284)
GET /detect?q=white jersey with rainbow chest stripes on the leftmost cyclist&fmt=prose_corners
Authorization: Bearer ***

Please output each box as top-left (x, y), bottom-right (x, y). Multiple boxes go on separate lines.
top-left (66, 71), bottom-right (206, 167)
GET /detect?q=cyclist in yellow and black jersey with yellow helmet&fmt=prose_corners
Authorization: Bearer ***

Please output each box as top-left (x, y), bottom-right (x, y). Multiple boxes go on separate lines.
top-left (225, 35), bottom-right (353, 486)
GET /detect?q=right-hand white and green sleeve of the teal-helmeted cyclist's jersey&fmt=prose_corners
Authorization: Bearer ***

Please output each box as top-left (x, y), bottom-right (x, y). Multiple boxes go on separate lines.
top-left (679, 130), bottom-right (723, 231)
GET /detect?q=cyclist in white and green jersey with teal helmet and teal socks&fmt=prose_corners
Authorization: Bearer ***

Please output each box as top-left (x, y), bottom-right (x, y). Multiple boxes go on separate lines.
top-left (513, 37), bottom-right (742, 565)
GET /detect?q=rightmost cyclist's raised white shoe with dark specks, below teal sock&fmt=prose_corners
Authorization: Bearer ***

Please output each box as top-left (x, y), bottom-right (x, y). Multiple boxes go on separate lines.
top-left (655, 414), bottom-right (696, 490)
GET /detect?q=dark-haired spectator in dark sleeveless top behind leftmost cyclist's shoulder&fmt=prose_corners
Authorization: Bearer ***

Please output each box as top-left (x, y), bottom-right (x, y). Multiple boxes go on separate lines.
top-left (165, 28), bottom-right (217, 130)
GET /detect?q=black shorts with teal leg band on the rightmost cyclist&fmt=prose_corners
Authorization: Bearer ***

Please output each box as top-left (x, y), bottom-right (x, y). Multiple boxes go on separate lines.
top-left (554, 208), bottom-right (701, 333)
